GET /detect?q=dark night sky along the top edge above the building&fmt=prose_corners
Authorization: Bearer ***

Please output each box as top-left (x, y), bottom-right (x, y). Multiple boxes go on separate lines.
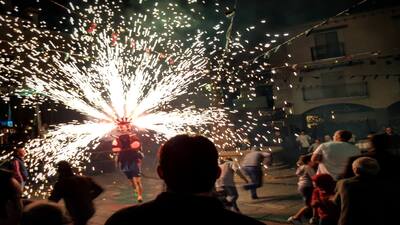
top-left (3, 0), bottom-right (400, 29)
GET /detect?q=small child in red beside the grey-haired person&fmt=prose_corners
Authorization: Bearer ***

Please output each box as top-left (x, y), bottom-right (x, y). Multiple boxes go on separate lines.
top-left (310, 174), bottom-right (339, 225)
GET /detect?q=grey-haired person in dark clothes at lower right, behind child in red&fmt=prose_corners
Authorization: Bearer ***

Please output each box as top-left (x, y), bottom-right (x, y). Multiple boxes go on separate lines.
top-left (335, 157), bottom-right (387, 225)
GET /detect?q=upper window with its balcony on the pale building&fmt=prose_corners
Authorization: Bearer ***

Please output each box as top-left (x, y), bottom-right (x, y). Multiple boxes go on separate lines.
top-left (311, 31), bottom-right (345, 60)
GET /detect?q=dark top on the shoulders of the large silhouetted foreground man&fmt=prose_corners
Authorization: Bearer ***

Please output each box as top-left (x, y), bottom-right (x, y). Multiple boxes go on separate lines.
top-left (105, 192), bottom-right (264, 225)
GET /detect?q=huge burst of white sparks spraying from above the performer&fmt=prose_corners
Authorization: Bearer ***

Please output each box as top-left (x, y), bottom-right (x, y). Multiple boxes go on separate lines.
top-left (0, 0), bottom-right (288, 195)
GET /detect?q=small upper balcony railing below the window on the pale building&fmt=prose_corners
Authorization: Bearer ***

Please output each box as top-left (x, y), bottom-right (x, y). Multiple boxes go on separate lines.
top-left (311, 42), bottom-right (345, 61)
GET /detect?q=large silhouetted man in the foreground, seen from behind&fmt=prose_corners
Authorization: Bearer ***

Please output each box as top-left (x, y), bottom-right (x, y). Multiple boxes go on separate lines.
top-left (106, 135), bottom-right (263, 225)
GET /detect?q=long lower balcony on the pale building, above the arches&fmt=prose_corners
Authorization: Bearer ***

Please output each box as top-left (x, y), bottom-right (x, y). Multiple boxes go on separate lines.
top-left (303, 82), bottom-right (368, 101)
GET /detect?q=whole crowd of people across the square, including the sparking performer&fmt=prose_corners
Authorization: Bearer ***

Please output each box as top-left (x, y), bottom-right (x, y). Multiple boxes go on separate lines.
top-left (0, 125), bottom-right (400, 225)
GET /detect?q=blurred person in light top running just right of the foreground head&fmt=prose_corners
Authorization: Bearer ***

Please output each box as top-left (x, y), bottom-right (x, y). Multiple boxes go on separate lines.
top-left (215, 157), bottom-right (249, 212)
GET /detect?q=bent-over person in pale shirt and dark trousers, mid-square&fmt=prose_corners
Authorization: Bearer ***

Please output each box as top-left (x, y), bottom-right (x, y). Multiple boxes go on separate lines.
top-left (242, 147), bottom-right (272, 199)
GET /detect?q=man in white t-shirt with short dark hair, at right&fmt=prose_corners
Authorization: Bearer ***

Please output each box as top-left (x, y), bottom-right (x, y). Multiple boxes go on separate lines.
top-left (311, 130), bottom-right (360, 180)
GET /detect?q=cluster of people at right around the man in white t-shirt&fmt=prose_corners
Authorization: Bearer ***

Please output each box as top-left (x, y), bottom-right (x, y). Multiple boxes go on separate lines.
top-left (288, 128), bottom-right (400, 225)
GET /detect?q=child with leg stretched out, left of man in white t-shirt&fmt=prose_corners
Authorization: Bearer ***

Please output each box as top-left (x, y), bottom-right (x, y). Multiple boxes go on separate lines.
top-left (288, 154), bottom-right (315, 224)
